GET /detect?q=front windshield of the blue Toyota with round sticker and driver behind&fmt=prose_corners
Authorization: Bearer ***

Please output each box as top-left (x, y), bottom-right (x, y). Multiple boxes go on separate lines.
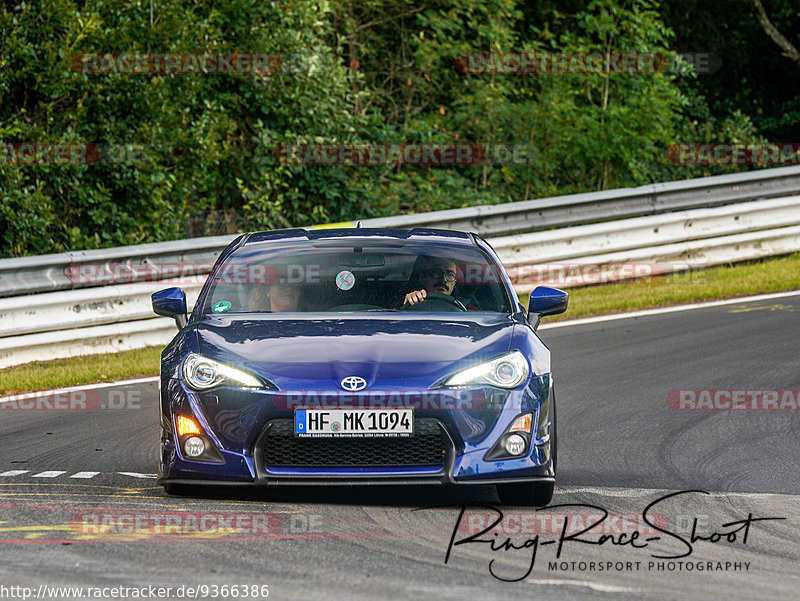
top-left (202, 239), bottom-right (510, 314)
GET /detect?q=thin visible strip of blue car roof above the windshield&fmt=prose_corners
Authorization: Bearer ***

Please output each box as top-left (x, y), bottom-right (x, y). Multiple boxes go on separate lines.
top-left (242, 228), bottom-right (475, 246)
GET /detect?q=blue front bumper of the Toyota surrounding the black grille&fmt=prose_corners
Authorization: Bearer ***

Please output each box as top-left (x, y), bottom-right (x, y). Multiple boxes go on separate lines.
top-left (158, 376), bottom-right (555, 486)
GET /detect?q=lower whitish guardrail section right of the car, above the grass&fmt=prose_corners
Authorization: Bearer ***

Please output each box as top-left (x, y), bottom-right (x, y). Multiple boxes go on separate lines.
top-left (491, 196), bottom-right (800, 293)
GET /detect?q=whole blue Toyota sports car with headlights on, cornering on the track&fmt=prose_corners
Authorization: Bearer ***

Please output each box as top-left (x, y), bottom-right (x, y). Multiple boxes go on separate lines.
top-left (152, 229), bottom-right (568, 505)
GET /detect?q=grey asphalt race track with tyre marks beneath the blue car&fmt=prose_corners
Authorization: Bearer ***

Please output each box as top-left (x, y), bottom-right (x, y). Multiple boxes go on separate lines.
top-left (0, 295), bottom-right (800, 601)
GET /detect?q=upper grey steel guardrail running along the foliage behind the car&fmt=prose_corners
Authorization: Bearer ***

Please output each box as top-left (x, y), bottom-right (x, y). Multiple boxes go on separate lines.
top-left (0, 166), bottom-right (800, 297)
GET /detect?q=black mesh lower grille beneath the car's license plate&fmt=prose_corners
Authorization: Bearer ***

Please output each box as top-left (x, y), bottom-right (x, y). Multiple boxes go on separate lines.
top-left (261, 418), bottom-right (450, 468)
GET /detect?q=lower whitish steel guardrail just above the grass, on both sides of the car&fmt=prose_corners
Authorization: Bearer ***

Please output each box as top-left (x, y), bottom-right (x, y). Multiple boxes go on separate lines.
top-left (0, 196), bottom-right (800, 368)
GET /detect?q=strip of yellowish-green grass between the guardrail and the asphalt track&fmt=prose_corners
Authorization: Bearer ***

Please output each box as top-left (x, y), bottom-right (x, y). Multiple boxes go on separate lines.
top-left (0, 253), bottom-right (800, 394)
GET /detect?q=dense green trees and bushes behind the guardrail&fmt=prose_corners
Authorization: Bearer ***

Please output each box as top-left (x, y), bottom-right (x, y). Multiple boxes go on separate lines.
top-left (0, 0), bottom-right (800, 257)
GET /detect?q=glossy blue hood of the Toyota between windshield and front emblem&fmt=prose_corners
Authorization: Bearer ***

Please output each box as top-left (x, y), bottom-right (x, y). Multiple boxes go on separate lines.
top-left (192, 313), bottom-right (515, 390)
